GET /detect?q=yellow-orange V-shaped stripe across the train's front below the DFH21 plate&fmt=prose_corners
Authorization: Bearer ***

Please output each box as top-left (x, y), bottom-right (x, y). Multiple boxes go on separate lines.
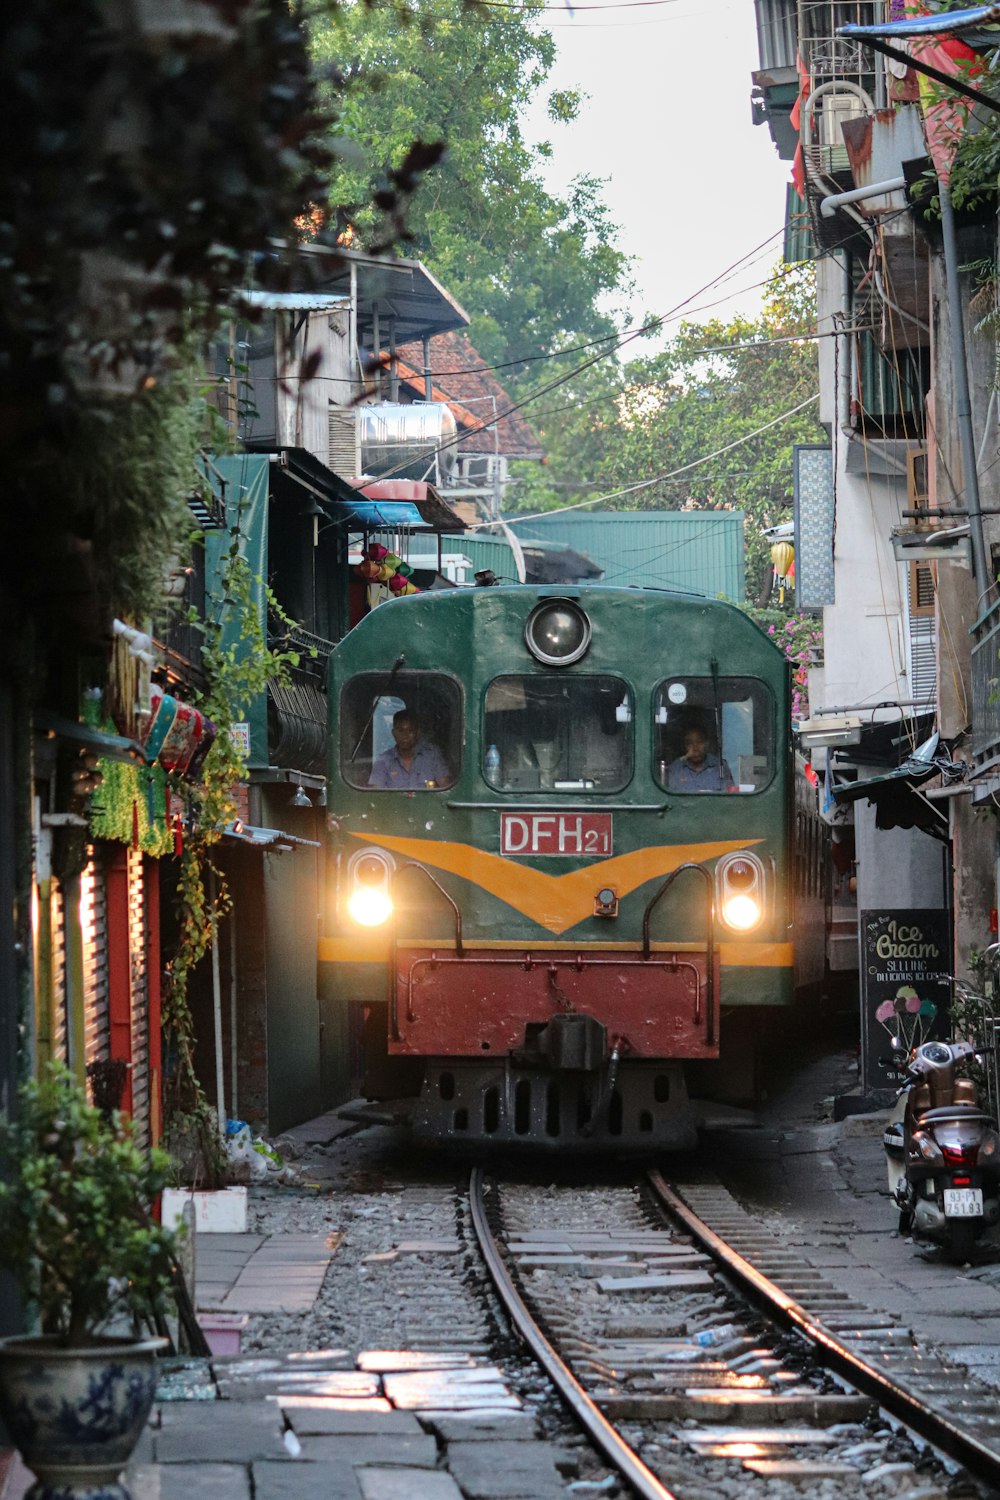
top-left (351, 834), bottom-right (762, 935)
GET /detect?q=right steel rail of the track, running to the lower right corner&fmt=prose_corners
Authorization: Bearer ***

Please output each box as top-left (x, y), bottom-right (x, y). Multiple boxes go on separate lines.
top-left (648, 1169), bottom-right (1000, 1485)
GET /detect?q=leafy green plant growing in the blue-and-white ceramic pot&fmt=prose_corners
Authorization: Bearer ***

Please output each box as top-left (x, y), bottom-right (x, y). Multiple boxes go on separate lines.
top-left (0, 1064), bottom-right (174, 1346)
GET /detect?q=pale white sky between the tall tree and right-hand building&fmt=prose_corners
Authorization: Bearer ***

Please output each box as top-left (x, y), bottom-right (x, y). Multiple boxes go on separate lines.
top-left (525, 0), bottom-right (789, 331)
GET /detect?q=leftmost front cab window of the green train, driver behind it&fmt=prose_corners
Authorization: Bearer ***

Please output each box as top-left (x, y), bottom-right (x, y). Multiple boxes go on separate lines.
top-left (340, 672), bottom-right (462, 792)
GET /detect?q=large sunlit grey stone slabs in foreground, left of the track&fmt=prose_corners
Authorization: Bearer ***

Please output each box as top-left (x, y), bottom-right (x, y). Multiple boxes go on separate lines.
top-left (0, 1350), bottom-right (577, 1500)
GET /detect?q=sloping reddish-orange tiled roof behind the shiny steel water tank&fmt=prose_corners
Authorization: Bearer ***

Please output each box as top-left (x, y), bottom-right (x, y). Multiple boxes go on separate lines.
top-left (396, 330), bottom-right (541, 459)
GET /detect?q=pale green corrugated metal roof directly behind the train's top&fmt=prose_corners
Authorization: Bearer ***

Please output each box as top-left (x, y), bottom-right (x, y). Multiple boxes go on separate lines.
top-left (503, 510), bottom-right (744, 600)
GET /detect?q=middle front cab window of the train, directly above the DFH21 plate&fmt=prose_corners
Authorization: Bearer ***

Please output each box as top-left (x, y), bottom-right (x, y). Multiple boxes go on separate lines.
top-left (483, 674), bottom-right (633, 794)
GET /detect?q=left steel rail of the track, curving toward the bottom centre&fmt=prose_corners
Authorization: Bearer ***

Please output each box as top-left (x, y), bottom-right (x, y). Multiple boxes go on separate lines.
top-left (469, 1167), bottom-right (675, 1500)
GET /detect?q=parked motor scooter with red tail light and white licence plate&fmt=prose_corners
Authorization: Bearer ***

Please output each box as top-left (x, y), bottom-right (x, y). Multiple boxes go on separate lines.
top-left (882, 1041), bottom-right (1000, 1265)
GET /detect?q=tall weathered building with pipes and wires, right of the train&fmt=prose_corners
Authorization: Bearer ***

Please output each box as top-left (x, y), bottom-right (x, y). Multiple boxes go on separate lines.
top-left (753, 0), bottom-right (1000, 1104)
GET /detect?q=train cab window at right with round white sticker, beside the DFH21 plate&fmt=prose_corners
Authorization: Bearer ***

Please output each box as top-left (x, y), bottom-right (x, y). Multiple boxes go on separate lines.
top-left (652, 677), bottom-right (775, 794)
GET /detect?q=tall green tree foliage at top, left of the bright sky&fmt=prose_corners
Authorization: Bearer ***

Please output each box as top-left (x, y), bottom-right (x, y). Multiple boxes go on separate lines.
top-left (312, 0), bottom-right (627, 378)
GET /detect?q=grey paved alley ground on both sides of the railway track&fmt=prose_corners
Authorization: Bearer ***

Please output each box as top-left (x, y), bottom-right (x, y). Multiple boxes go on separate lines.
top-left (9, 1026), bottom-right (1000, 1500)
